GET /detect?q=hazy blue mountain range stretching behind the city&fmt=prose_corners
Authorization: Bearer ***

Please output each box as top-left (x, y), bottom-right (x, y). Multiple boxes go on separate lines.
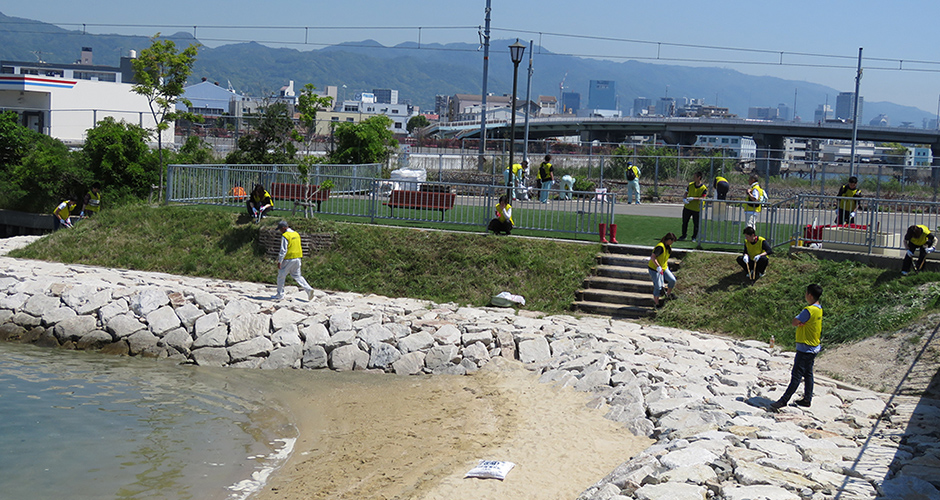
top-left (0, 13), bottom-right (935, 128)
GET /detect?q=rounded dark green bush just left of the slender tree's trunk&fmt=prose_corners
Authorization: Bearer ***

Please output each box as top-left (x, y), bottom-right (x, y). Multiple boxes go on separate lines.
top-left (82, 116), bottom-right (162, 199)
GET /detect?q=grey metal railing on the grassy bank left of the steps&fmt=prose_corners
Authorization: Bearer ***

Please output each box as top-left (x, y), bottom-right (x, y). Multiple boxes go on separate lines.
top-left (167, 165), bottom-right (617, 234)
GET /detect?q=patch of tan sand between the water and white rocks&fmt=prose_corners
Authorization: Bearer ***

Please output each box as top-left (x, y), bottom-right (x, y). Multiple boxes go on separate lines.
top-left (252, 359), bottom-right (652, 500)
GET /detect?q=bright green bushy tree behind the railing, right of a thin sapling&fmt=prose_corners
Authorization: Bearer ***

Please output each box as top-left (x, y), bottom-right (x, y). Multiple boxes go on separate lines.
top-left (330, 115), bottom-right (398, 164)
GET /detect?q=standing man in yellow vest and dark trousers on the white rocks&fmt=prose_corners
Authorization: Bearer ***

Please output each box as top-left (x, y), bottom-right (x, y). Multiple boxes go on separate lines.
top-left (770, 284), bottom-right (822, 411)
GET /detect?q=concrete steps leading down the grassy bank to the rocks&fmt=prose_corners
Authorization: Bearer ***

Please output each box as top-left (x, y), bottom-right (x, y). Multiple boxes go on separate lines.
top-left (573, 245), bottom-right (684, 318)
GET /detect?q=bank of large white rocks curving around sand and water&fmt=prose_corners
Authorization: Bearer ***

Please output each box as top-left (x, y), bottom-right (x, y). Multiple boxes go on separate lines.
top-left (0, 235), bottom-right (940, 500)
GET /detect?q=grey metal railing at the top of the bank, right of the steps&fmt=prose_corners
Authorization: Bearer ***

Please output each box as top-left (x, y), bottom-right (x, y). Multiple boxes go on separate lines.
top-left (698, 194), bottom-right (940, 256)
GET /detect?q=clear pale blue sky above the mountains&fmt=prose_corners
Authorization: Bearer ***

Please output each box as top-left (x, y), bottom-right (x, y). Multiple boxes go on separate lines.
top-left (0, 0), bottom-right (940, 113)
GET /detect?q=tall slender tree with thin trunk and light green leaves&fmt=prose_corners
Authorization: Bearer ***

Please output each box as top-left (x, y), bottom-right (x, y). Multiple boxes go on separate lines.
top-left (132, 33), bottom-right (201, 199)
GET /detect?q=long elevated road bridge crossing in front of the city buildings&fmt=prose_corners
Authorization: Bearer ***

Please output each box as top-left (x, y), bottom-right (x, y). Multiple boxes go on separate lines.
top-left (427, 115), bottom-right (940, 172)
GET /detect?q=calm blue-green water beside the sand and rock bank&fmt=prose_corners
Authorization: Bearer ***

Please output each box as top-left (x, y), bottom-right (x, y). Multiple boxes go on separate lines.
top-left (0, 342), bottom-right (295, 500)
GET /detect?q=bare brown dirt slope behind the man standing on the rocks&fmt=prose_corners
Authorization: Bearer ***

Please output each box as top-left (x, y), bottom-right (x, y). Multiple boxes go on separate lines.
top-left (815, 314), bottom-right (940, 399)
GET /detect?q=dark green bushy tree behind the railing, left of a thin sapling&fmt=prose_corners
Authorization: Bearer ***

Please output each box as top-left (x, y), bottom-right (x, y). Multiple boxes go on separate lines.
top-left (225, 102), bottom-right (297, 164)
